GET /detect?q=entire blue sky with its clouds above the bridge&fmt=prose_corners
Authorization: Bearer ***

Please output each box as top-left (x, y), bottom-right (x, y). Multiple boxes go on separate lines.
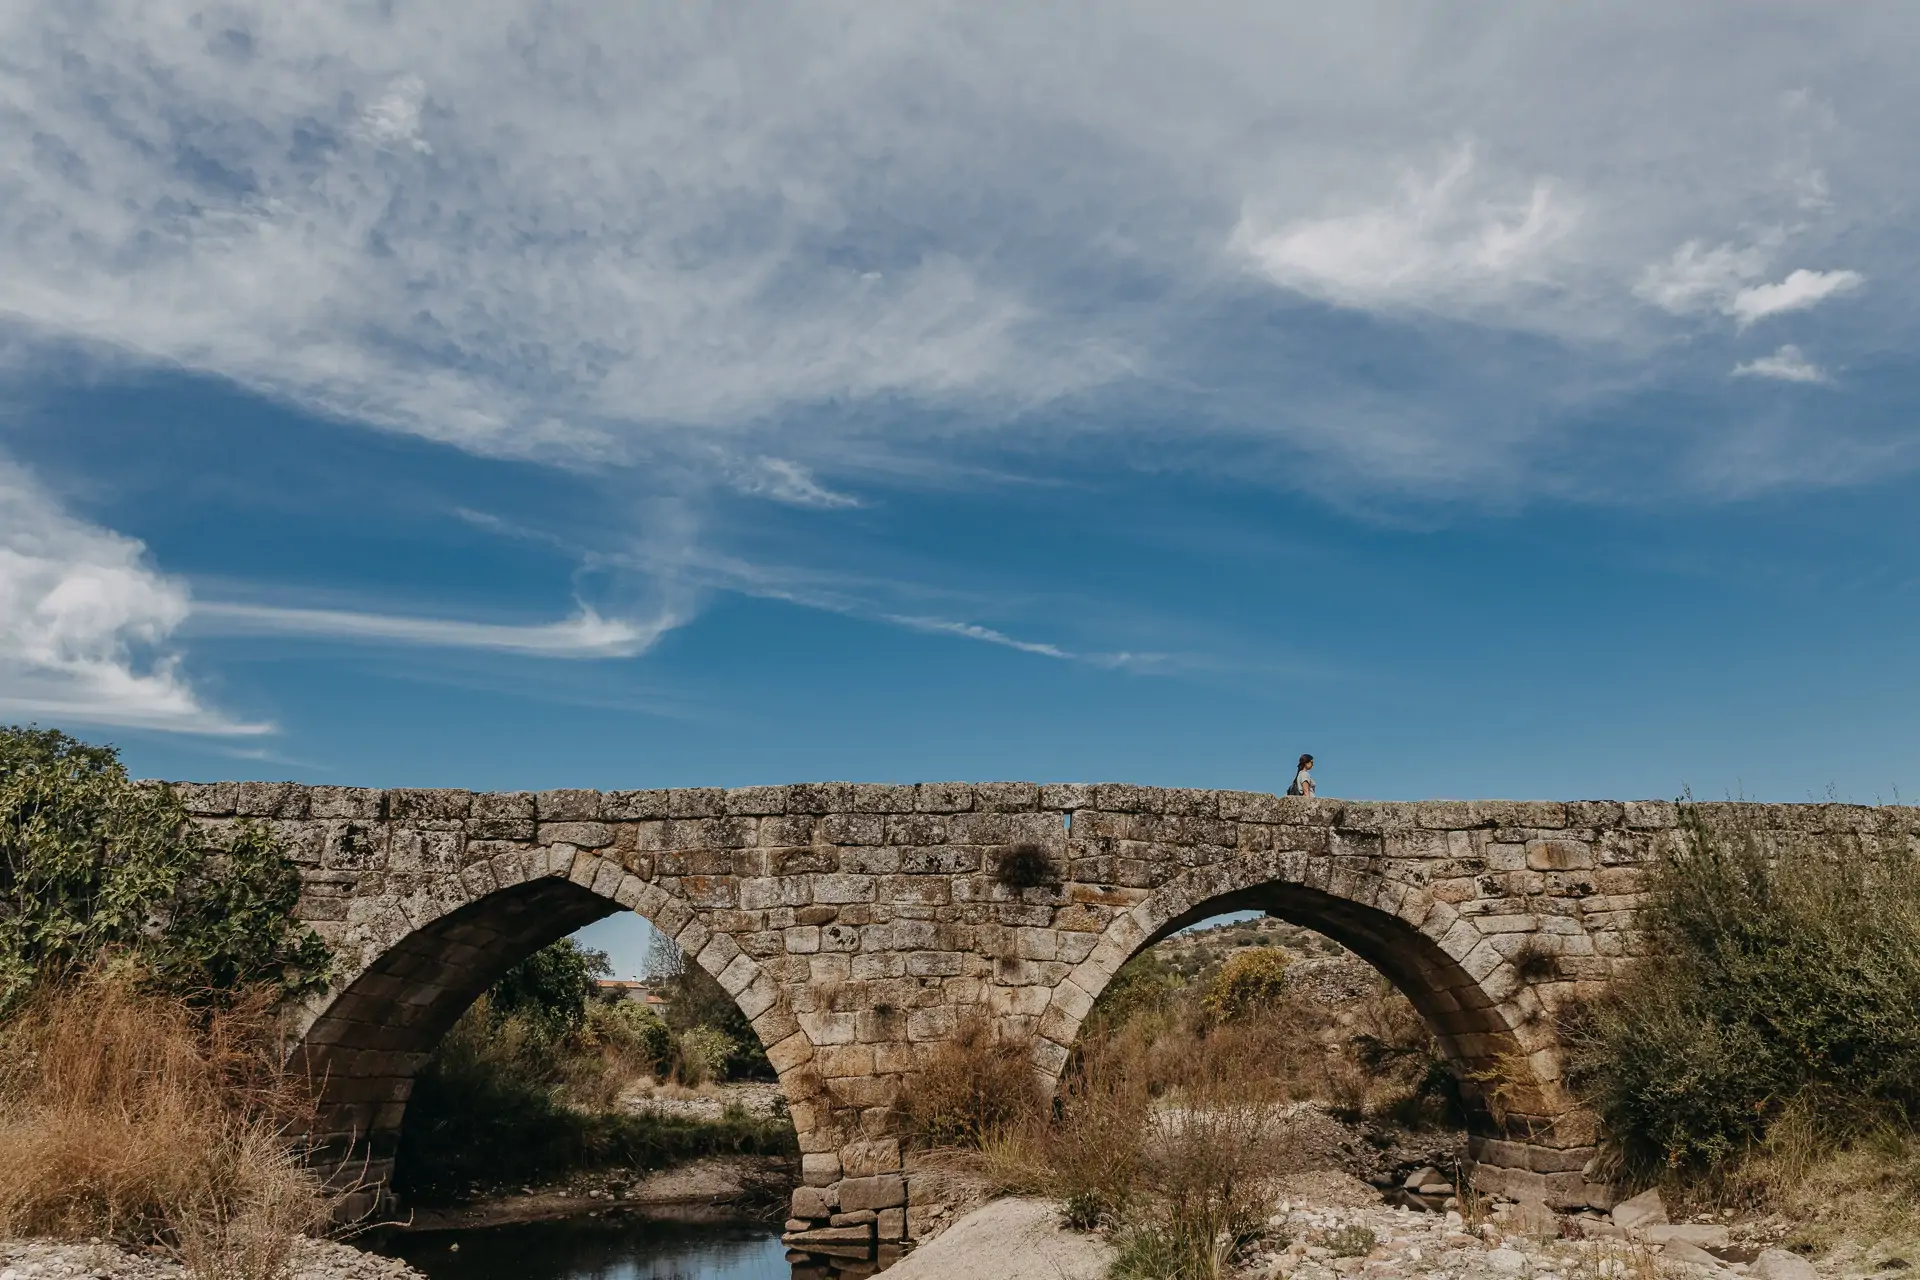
top-left (0, 0), bottom-right (1920, 967)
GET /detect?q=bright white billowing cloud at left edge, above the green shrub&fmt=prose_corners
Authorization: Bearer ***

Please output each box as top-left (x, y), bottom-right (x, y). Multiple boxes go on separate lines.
top-left (0, 462), bottom-right (269, 733)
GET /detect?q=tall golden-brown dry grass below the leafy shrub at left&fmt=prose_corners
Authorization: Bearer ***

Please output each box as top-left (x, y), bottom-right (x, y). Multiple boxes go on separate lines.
top-left (0, 977), bottom-right (328, 1280)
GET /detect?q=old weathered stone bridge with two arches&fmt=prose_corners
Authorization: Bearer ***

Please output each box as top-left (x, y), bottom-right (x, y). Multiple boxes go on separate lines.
top-left (177, 783), bottom-right (1920, 1240)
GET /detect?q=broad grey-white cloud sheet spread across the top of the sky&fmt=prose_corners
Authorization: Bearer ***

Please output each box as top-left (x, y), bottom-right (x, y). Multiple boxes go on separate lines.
top-left (0, 0), bottom-right (1920, 507)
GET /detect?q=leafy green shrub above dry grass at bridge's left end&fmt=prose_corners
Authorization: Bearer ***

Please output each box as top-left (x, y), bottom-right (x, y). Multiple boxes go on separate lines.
top-left (0, 727), bottom-right (330, 1015)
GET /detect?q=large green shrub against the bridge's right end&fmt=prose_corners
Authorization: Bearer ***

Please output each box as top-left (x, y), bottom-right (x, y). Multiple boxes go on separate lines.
top-left (1569, 806), bottom-right (1920, 1176)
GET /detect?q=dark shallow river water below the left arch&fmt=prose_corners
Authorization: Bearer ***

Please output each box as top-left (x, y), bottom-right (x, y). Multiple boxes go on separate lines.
top-left (378, 1219), bottom-right (793, 1280)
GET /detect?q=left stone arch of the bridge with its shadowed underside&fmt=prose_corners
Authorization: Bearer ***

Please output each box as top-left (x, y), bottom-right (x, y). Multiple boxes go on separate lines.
top-left (290, 846), bottom-right (824, 1217)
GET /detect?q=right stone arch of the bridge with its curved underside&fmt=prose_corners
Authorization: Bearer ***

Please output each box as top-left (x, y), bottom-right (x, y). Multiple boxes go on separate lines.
top-left (1035, 852), bottom-right (1594, 1205)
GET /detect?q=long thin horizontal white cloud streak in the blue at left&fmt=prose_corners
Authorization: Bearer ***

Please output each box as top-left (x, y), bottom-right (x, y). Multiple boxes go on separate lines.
top-left (194, 601), bottom-right (685, 658)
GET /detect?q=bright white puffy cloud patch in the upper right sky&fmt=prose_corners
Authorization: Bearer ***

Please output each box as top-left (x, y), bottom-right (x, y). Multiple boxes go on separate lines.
top-left (1233, 146), bottom-right (1578, 311)
